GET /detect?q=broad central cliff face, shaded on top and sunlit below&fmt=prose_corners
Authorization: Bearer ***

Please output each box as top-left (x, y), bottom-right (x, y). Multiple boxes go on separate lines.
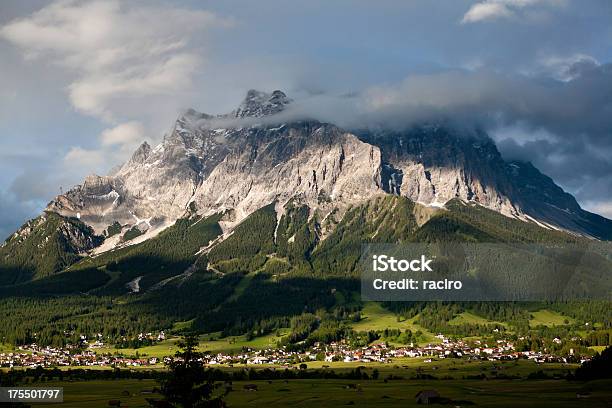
top-left (193, 122), bottom-right (384, 230)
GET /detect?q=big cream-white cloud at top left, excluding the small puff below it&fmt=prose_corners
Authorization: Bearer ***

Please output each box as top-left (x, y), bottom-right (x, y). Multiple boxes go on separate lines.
top-left (0, 0), bottom-right (232, 121)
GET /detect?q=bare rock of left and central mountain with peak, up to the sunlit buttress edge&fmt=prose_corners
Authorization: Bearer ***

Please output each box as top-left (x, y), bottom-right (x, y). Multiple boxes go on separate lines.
top-left (47, 91), bottom-right (384, 233)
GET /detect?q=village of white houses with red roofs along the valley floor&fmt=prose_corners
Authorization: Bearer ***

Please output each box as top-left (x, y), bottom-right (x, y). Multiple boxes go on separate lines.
top-left (0, 335), bottom-right (585, 368)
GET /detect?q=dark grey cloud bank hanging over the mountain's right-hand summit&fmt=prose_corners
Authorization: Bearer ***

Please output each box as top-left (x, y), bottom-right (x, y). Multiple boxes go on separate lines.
top-left (356, 61), bottom-right (612, 137)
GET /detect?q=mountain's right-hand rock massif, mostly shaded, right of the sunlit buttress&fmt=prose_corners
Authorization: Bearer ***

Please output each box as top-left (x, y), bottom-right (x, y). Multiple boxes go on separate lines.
top-left (358, 125), bottom-right (612, 240)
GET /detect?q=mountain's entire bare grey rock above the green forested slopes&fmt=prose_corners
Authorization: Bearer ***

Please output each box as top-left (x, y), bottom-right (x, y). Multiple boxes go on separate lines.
top-left (47, 90), bottom-right (612, 245)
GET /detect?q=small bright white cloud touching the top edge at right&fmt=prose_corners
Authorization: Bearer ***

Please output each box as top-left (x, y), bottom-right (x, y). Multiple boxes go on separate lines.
top-left (461, 0), bottom-right (566, 24)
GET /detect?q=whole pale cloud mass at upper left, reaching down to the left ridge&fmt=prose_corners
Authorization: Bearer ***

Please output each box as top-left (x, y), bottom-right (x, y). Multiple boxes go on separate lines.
top-left (0, 0), bottom-right (233, 185)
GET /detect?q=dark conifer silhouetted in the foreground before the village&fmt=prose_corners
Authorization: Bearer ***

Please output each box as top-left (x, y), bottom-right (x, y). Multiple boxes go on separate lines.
top-left (162, 335), bottom-right (226, 408)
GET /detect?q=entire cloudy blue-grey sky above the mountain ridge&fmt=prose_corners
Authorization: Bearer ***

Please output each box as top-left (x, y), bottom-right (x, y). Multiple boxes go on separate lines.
top-left (0, 0), bottom-right (612, 238)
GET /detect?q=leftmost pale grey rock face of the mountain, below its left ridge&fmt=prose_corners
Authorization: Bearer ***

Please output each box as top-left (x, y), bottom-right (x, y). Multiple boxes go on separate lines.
top-left (47, 107), bottom-right (229, 232)
